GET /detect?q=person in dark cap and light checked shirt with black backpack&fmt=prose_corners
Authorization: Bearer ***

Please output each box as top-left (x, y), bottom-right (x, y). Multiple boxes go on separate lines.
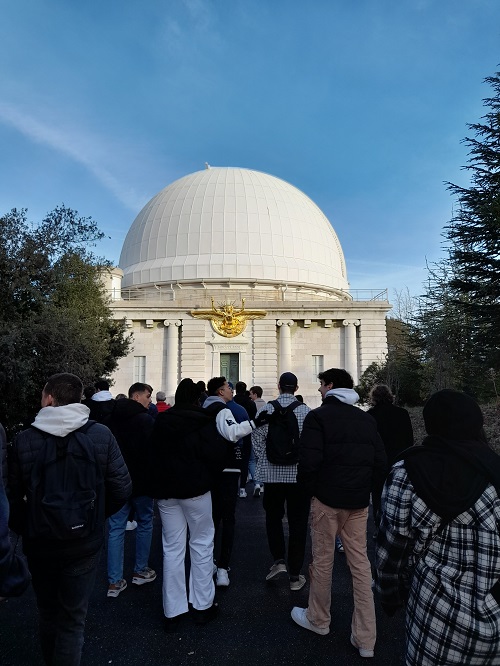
top-left (252, 372), bottom-right (310, 591)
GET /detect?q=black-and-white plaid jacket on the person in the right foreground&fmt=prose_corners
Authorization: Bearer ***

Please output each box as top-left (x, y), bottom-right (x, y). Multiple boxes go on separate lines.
top-left (376, 462), bottom-right (500, 666)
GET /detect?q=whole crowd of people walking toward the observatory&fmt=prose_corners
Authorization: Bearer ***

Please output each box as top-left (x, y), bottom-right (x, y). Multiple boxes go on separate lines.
top-left (0, 368), bottom-right (500, 666)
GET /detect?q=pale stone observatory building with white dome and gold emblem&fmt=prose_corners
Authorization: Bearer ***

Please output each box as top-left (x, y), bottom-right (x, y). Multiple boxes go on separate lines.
top-left (107, 165), bottom-right (390, 407)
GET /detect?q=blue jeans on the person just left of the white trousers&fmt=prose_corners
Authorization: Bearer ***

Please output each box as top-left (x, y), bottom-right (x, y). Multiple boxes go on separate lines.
top-left (108, 495), bottom-right (153, 584)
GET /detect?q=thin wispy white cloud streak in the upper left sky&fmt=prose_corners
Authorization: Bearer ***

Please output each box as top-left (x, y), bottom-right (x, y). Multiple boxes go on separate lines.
top-left (0, 102), bottom-right (144, 211)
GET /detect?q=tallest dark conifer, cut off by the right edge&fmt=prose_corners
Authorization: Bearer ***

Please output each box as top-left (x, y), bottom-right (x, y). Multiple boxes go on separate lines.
top-left (445, 72), bottom-right (500, 374)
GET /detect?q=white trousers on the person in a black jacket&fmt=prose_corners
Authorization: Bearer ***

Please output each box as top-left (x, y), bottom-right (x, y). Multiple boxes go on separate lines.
top-left (158, 492), bottom-right (215, 617)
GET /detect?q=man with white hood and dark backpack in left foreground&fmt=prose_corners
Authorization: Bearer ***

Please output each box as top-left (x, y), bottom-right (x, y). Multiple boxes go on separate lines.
top-left (9, 373), bottom-right (132, 666)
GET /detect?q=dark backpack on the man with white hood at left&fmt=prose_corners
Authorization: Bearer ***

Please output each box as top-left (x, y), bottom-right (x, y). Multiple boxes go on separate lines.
top-left (27, 421), bottom-right (105, 540)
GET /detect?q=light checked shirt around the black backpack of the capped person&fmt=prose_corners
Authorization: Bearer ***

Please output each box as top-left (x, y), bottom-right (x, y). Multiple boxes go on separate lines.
top-left (252, 393), bottom-right (311, 483)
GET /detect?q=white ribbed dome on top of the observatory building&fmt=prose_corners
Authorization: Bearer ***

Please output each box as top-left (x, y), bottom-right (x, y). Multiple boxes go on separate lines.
top-left (120, 167), bottom-right (349, 290)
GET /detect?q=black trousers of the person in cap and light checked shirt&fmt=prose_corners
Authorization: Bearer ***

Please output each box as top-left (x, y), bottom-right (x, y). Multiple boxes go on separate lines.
top-left (263, 483), bottom-right (310, 576)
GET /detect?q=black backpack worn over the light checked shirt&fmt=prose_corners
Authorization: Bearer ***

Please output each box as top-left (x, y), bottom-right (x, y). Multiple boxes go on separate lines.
top-left (266, 400), bottom-right (302, 465)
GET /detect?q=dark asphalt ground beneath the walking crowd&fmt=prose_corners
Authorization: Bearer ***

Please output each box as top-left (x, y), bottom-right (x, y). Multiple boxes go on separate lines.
top-left (0, 484), bottom-right (404, 666)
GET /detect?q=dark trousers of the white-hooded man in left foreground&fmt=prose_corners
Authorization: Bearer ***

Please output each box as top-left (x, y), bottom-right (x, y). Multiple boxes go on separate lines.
top-left (28, 551), bottom-right (100, 666)
